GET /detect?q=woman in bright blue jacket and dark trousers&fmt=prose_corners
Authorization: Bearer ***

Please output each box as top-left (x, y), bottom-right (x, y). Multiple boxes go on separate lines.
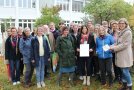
top-left (96, 26), bottom-right (114, 87)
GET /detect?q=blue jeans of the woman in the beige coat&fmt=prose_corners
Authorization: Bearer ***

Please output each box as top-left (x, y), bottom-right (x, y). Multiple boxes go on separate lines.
top-left (121, 68), bottom-right (132, 86)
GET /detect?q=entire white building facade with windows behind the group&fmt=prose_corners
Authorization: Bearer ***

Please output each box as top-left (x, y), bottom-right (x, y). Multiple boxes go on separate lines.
top-left (0, 0), bottom-right (85, 30)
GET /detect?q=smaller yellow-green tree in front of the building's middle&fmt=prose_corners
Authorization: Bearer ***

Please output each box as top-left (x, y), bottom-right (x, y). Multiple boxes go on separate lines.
top-left (35, 6), bottom-right (61, 26)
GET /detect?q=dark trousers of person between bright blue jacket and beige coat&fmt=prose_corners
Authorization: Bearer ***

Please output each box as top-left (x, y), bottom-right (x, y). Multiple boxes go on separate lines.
top-left (113, 53), bottom-right (122, 80)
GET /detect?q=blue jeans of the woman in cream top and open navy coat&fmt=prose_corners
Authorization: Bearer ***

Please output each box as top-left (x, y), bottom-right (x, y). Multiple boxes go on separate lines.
top-left (36, 56), bottom-right (45, 83)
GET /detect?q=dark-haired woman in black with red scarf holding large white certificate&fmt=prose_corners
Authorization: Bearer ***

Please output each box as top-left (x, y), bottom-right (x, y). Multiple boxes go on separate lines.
top-left (77, 26), bottom-right (95, 86)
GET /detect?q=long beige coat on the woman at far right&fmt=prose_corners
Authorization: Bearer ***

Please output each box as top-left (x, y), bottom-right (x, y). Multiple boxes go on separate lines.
top-left (114, 28), bottom-right (133, 68)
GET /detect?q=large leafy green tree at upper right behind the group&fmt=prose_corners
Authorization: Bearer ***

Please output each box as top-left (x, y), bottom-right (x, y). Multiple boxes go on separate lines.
top-left (84, 0), bottom-right (133, 23)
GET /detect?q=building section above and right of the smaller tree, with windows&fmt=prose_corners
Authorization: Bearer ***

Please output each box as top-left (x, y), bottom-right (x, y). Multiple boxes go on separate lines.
top-left (40, 0), bottom-right (86, 26)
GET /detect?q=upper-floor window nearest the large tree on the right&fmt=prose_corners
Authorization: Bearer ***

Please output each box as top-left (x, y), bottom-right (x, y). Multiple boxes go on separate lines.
top-left (72, 0), bottom-right (83, 12)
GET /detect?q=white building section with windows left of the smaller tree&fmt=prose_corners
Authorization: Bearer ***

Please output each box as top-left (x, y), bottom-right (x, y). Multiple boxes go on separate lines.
top-left (0, 0), bottom-right (40, 29)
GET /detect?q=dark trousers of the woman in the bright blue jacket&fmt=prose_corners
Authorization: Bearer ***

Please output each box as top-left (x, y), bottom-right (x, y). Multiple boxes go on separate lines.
top-left (99, 58), bottom-right (113, 84)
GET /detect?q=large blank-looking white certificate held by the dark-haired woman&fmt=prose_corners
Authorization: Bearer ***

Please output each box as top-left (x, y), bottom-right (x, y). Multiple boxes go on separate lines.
top-left (80, 44), bottom-right (89, 57)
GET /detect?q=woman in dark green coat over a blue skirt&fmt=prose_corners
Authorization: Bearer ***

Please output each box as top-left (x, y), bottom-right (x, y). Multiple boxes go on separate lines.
top-left (56, 27), bottom-right (75, 85)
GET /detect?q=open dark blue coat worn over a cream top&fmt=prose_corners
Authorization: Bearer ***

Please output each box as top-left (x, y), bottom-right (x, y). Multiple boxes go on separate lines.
top-left (31, 36), bottom-right (50, 66)
